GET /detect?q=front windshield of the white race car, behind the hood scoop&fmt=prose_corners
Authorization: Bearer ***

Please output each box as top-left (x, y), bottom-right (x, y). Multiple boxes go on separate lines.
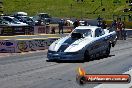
top-left (72, 29), bottom-right (92, 37)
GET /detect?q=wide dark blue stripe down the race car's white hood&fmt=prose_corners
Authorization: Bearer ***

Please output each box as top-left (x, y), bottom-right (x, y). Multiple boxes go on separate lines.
top-left (58, 37), bottom-right (77, 52)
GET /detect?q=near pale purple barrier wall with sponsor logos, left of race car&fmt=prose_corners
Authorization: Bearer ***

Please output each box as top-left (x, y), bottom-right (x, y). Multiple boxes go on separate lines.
top-left (0, 37), bottom-right (60, 53)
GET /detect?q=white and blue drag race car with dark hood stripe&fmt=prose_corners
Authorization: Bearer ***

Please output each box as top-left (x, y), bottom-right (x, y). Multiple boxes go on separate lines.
top-left (47, 26), bottom-right (117, 60)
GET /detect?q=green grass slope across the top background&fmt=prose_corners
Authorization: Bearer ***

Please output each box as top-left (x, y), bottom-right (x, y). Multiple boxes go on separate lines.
top-left (3, 0), bottom-right (130, 19)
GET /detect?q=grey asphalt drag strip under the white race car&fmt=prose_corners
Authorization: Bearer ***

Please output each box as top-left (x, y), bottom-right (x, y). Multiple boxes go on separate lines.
top-left (0, 39), bottom-right (132, 88)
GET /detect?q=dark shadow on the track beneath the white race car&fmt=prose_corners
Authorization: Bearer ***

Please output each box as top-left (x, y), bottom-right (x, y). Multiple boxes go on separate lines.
top-left (46, 55), bottom-right (115, 63)
